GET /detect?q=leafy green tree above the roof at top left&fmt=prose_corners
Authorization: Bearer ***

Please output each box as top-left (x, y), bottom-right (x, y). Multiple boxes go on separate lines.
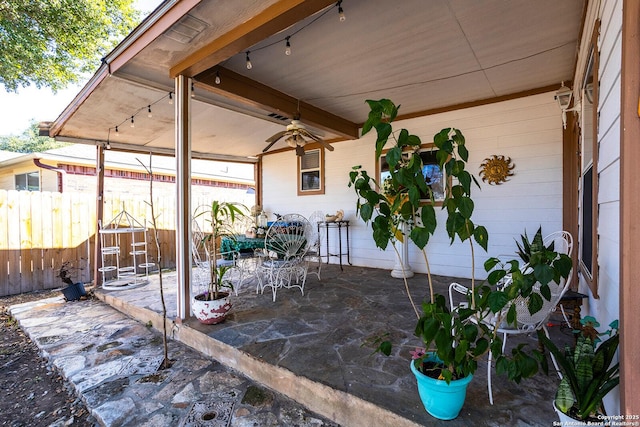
top-left (0, 0), bottom-right (139, 92)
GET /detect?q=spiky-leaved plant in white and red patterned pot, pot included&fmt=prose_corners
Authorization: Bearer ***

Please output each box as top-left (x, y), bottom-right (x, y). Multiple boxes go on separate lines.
top-left (192, 201), bottom-right (245, 324)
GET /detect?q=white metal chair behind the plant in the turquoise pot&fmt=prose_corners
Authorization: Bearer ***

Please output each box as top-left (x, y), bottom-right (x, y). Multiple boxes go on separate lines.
top-left (449, 231), bottom-right (573, 405)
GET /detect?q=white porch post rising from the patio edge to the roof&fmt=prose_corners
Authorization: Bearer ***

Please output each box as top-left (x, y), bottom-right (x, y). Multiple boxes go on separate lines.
top-left (175, 75), bottom-right (191, 321)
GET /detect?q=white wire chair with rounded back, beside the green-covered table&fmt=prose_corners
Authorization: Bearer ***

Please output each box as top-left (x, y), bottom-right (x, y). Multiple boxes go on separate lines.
top-left (256, 214), bottom-right (312, 302)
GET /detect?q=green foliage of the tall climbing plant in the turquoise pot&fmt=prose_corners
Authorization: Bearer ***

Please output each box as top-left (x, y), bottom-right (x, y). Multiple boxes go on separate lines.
top-left (349, 99), bottom-right (571, 388)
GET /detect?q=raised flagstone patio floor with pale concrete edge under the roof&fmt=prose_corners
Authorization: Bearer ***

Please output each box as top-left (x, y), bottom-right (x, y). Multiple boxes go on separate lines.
top-left (96, 265), bottom-right (571, 427)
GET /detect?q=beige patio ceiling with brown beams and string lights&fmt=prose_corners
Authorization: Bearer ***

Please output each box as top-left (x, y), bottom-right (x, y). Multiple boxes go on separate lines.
top-left (50, 0), bottom-right (585, 161)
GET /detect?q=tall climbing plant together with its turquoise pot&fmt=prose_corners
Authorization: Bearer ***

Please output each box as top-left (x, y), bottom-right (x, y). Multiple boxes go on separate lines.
top-left (349, 99), bottom-right (556, 419)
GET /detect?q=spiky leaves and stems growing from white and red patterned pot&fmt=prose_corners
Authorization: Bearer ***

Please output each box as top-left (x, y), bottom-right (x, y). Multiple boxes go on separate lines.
top-left (194, 200), bottom-right (247, 301)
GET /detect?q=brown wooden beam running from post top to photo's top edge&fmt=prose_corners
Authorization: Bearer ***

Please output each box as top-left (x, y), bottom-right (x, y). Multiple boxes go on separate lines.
top-left (169, 0), bottom-right (335, 77)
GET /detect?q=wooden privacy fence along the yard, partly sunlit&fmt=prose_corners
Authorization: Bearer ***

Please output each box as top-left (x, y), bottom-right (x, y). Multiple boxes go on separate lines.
top-left (0, 190), bottom-right (176, 296)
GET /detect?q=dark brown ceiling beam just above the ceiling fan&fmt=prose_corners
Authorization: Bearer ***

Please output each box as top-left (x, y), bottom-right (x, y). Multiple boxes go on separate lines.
top-left (196, 67), bottom-right (359, 139)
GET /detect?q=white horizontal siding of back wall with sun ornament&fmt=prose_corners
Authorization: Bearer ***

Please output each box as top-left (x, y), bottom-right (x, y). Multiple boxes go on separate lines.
top-left (263, 93), bottom-right (562, 278)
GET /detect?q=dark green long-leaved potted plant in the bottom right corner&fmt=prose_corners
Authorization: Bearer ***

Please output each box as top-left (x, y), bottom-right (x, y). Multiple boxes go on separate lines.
top-left (538, 316), bottom-right (620, 425)
